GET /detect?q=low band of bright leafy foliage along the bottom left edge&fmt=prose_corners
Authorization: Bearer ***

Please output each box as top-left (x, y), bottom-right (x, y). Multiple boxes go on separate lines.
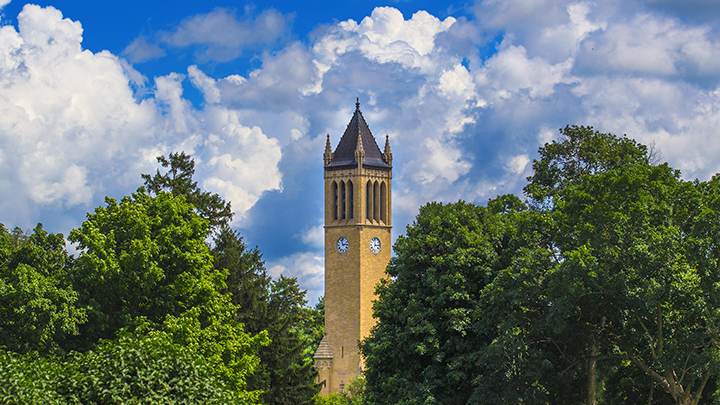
top-left (0, 313), bottom-right (267, 404)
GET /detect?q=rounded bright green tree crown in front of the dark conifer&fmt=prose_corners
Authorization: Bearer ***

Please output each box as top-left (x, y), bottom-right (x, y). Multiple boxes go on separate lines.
top-left (69, 192), bottom-right (227, 350)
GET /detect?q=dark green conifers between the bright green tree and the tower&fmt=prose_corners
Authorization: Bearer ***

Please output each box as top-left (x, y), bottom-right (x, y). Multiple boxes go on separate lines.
top-left (142, 153), bottom-right (323, 404)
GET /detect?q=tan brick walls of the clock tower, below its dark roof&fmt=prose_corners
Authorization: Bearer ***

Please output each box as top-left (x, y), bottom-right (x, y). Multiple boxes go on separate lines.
top-left (320, 163), bottom-right (392, 392)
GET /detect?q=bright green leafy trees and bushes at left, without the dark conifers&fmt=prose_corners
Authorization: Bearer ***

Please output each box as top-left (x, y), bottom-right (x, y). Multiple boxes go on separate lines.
top-left (0, 190), bottom-right (269, 404)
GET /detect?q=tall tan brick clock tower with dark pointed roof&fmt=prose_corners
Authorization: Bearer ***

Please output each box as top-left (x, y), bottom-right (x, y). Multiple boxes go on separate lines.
top-left (314, 101), bottom-right (392, 395)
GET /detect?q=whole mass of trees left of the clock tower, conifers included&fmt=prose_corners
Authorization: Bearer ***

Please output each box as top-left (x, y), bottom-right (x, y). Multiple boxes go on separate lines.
top-left (0, 153), bottom-right (323, 404)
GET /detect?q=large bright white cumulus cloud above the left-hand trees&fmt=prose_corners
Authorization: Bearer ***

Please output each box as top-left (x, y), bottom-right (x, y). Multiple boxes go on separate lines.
top-left (0, 5), bottom-right (281, 226)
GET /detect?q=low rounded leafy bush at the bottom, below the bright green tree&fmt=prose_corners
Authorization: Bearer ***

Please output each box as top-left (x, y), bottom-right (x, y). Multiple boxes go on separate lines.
top-left (58, 330), bottom-right (258, 404)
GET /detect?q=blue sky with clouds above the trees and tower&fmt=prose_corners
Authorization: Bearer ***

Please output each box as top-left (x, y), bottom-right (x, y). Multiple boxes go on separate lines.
top-left (0, 0), bottom-right (720, 302)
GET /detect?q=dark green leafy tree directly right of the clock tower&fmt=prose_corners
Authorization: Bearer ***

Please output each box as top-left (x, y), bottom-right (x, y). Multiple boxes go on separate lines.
top-left (361, 196), bottom-right (540, 404)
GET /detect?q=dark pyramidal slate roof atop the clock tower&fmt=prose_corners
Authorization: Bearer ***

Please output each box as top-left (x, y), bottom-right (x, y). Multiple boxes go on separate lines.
top-left (325, 102), bottom-right (392, 169)
